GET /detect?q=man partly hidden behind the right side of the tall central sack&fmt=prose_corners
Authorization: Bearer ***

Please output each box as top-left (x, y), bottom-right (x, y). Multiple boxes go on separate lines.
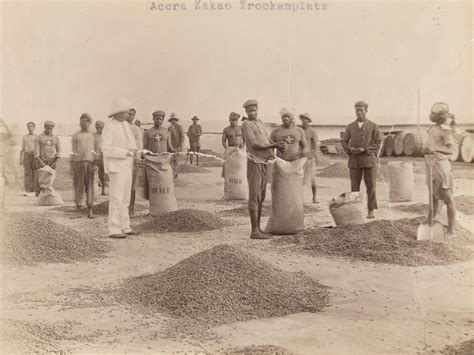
top-left (300, 113), bottom-right (319, 203)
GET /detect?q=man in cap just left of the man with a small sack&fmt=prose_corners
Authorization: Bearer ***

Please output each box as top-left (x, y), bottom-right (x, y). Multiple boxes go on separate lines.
top-left (20, 122), bottom-right (38, 196)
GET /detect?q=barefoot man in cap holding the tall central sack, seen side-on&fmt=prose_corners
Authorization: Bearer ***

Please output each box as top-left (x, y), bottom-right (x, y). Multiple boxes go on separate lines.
top-left (242, 99), bottom-right (287, 239)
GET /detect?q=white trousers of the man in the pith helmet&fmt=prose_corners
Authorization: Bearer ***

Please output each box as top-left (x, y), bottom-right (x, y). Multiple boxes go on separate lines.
top-left (108, 159), bottom-right (133, 235)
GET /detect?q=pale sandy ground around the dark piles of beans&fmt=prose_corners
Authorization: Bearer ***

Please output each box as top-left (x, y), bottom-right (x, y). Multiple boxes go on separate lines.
top-left (0, 159), bottom-right (474, 354)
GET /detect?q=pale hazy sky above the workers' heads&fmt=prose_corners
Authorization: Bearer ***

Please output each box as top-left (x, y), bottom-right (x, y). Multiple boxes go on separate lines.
top-left (0, 0), bottom-right (473, 134)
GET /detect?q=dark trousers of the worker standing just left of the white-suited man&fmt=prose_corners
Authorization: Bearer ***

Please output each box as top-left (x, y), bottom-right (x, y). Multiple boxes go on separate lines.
top-left (73, 161), bottom-right (94, 207)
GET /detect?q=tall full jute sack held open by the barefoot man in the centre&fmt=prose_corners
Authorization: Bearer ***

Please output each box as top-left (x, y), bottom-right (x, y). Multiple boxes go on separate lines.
top-left (265, 158), bottom-right (307, 234)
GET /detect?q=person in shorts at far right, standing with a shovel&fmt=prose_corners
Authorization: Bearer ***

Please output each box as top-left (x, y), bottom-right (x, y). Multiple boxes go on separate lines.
top-left (425, 102), bottom-right (456, 236)
